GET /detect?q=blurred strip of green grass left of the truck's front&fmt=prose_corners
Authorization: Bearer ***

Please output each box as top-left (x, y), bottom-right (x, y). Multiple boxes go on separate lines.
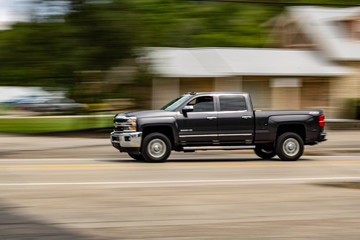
top-left (0, 116), bottom-right (113, 133)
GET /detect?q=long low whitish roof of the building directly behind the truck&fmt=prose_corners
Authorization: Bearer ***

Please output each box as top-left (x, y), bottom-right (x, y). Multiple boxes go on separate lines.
top-left (147, 48), bottom-right (350, 77)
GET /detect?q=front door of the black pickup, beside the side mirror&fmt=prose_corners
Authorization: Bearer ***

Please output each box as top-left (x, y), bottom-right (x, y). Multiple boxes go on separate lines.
top-left (178, 96), bottom-right (217, 145)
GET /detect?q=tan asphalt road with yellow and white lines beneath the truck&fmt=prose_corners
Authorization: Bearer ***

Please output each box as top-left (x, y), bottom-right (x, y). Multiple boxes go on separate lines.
top-left (0, 146), bottom-right (360, 240)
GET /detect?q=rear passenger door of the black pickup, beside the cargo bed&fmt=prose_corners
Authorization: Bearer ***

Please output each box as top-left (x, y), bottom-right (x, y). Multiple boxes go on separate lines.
top-left (218, 94), bottom-right (254, 144)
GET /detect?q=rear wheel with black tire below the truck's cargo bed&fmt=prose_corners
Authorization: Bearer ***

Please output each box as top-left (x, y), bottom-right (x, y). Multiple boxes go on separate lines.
top-left (275, 132), bottom-right (304, 161)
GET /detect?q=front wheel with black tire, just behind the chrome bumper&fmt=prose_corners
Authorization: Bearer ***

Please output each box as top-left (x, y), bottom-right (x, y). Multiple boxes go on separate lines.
top-left (141, 133), bottom-right (171, 162)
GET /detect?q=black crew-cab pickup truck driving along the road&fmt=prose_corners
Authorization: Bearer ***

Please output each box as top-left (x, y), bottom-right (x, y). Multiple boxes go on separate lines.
top-left (111, 92), bottom-right (326, 162)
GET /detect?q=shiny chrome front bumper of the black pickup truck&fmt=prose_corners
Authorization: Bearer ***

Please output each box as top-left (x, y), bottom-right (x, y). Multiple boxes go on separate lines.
top-left (110, 132), bottom-right (142, 151)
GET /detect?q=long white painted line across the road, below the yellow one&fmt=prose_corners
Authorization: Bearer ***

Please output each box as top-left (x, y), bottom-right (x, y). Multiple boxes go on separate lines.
top-left (0, 176), bottom-right (360, 187)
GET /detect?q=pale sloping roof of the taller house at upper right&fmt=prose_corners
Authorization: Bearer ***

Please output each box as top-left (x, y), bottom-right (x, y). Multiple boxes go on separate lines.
top-left (287, 6), bottom-right (360, 61)
